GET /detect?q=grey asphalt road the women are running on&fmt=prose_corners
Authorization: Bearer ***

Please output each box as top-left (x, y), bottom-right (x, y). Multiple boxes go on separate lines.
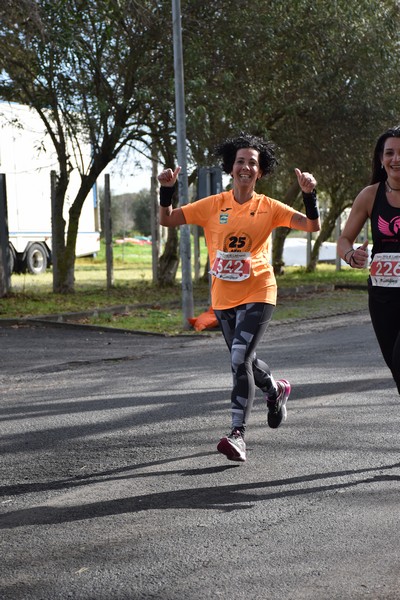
top-left (0, 313), bottom-right (400, 600)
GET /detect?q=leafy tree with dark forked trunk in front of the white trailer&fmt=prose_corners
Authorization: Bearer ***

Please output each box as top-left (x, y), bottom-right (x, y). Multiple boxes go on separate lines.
top-left (0, 0), bottom-right (170, 292)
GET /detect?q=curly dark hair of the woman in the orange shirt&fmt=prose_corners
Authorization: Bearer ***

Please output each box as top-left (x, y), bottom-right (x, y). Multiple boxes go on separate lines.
top-left (215, 132), bottom-right (277, 177)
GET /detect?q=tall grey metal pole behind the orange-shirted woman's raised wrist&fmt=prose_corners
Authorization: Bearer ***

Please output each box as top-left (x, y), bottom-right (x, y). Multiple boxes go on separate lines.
top-left (172, 0), bottom-right (194, 329)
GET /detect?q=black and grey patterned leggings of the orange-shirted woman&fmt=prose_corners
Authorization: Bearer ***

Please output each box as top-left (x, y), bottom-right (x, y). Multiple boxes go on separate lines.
top-left (214, 302), bottom-right (277, 431)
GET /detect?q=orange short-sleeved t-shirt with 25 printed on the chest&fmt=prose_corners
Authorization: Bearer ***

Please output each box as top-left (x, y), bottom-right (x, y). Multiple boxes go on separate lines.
top-left (182, 191), bottom-right (297, 310)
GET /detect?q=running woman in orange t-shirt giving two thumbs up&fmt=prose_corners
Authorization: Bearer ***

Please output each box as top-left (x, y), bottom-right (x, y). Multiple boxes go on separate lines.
top-left (158, 133), bottom-right (320, 462)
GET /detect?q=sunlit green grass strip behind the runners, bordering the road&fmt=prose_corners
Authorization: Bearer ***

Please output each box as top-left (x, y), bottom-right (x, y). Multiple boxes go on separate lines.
top-left (0, 238), bottom-right (368, 334)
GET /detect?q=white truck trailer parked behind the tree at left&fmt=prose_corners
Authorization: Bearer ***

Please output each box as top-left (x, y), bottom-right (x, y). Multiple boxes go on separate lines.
top-left (0, 102), bottom-right (100, 274)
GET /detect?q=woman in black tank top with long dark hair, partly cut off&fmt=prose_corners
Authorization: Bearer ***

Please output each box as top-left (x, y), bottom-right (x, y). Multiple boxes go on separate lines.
top-left (338, 126), bottom-right (400, 394)
